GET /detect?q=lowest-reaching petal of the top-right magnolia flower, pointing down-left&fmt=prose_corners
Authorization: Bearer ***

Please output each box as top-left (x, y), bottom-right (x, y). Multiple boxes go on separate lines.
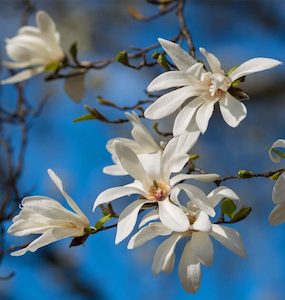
top-left (173, 97), bottom-right (205, 136)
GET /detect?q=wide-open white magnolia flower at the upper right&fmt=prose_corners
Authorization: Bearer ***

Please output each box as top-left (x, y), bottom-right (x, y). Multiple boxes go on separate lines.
top-left (145, 39), bottom-right (281, 136)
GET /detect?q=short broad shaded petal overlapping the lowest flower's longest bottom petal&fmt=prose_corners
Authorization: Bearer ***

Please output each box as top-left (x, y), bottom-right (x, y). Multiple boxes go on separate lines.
top-left (191, 232), bottom-right (214, 266)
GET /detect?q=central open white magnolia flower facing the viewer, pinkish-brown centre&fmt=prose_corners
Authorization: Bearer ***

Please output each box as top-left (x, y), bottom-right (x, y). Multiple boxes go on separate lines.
top-left (93, 138), bottom-right (220, 244)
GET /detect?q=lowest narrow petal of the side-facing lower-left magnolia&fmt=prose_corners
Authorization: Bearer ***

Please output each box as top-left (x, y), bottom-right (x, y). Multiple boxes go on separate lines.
top-left (11, 228), bottom-right (73, 256)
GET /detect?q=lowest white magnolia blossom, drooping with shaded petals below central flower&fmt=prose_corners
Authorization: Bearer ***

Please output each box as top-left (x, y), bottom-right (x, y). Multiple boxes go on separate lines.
top-left (128, 187), bottom-right (245, 293)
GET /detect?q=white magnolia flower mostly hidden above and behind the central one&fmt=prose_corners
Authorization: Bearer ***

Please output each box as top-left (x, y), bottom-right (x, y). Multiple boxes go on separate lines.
top-left (103, 112), bottom-right (200, 176)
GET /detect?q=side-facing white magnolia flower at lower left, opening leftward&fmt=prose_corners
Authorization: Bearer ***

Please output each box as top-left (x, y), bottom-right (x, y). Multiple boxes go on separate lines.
top-left (8, 169), bottom-right (90, 256)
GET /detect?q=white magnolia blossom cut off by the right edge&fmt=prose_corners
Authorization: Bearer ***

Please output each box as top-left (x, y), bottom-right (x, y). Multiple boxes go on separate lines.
top-left (269, 139), bottom-right (285, 225)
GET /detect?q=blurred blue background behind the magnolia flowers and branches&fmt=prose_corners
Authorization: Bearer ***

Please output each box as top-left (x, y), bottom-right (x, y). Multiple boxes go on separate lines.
top-left (0, 0), bottom-right (285, 300)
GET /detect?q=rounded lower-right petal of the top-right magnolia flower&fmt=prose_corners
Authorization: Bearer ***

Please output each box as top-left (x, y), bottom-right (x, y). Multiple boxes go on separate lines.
top-left (219, 93), bottom-right (247, 127)
